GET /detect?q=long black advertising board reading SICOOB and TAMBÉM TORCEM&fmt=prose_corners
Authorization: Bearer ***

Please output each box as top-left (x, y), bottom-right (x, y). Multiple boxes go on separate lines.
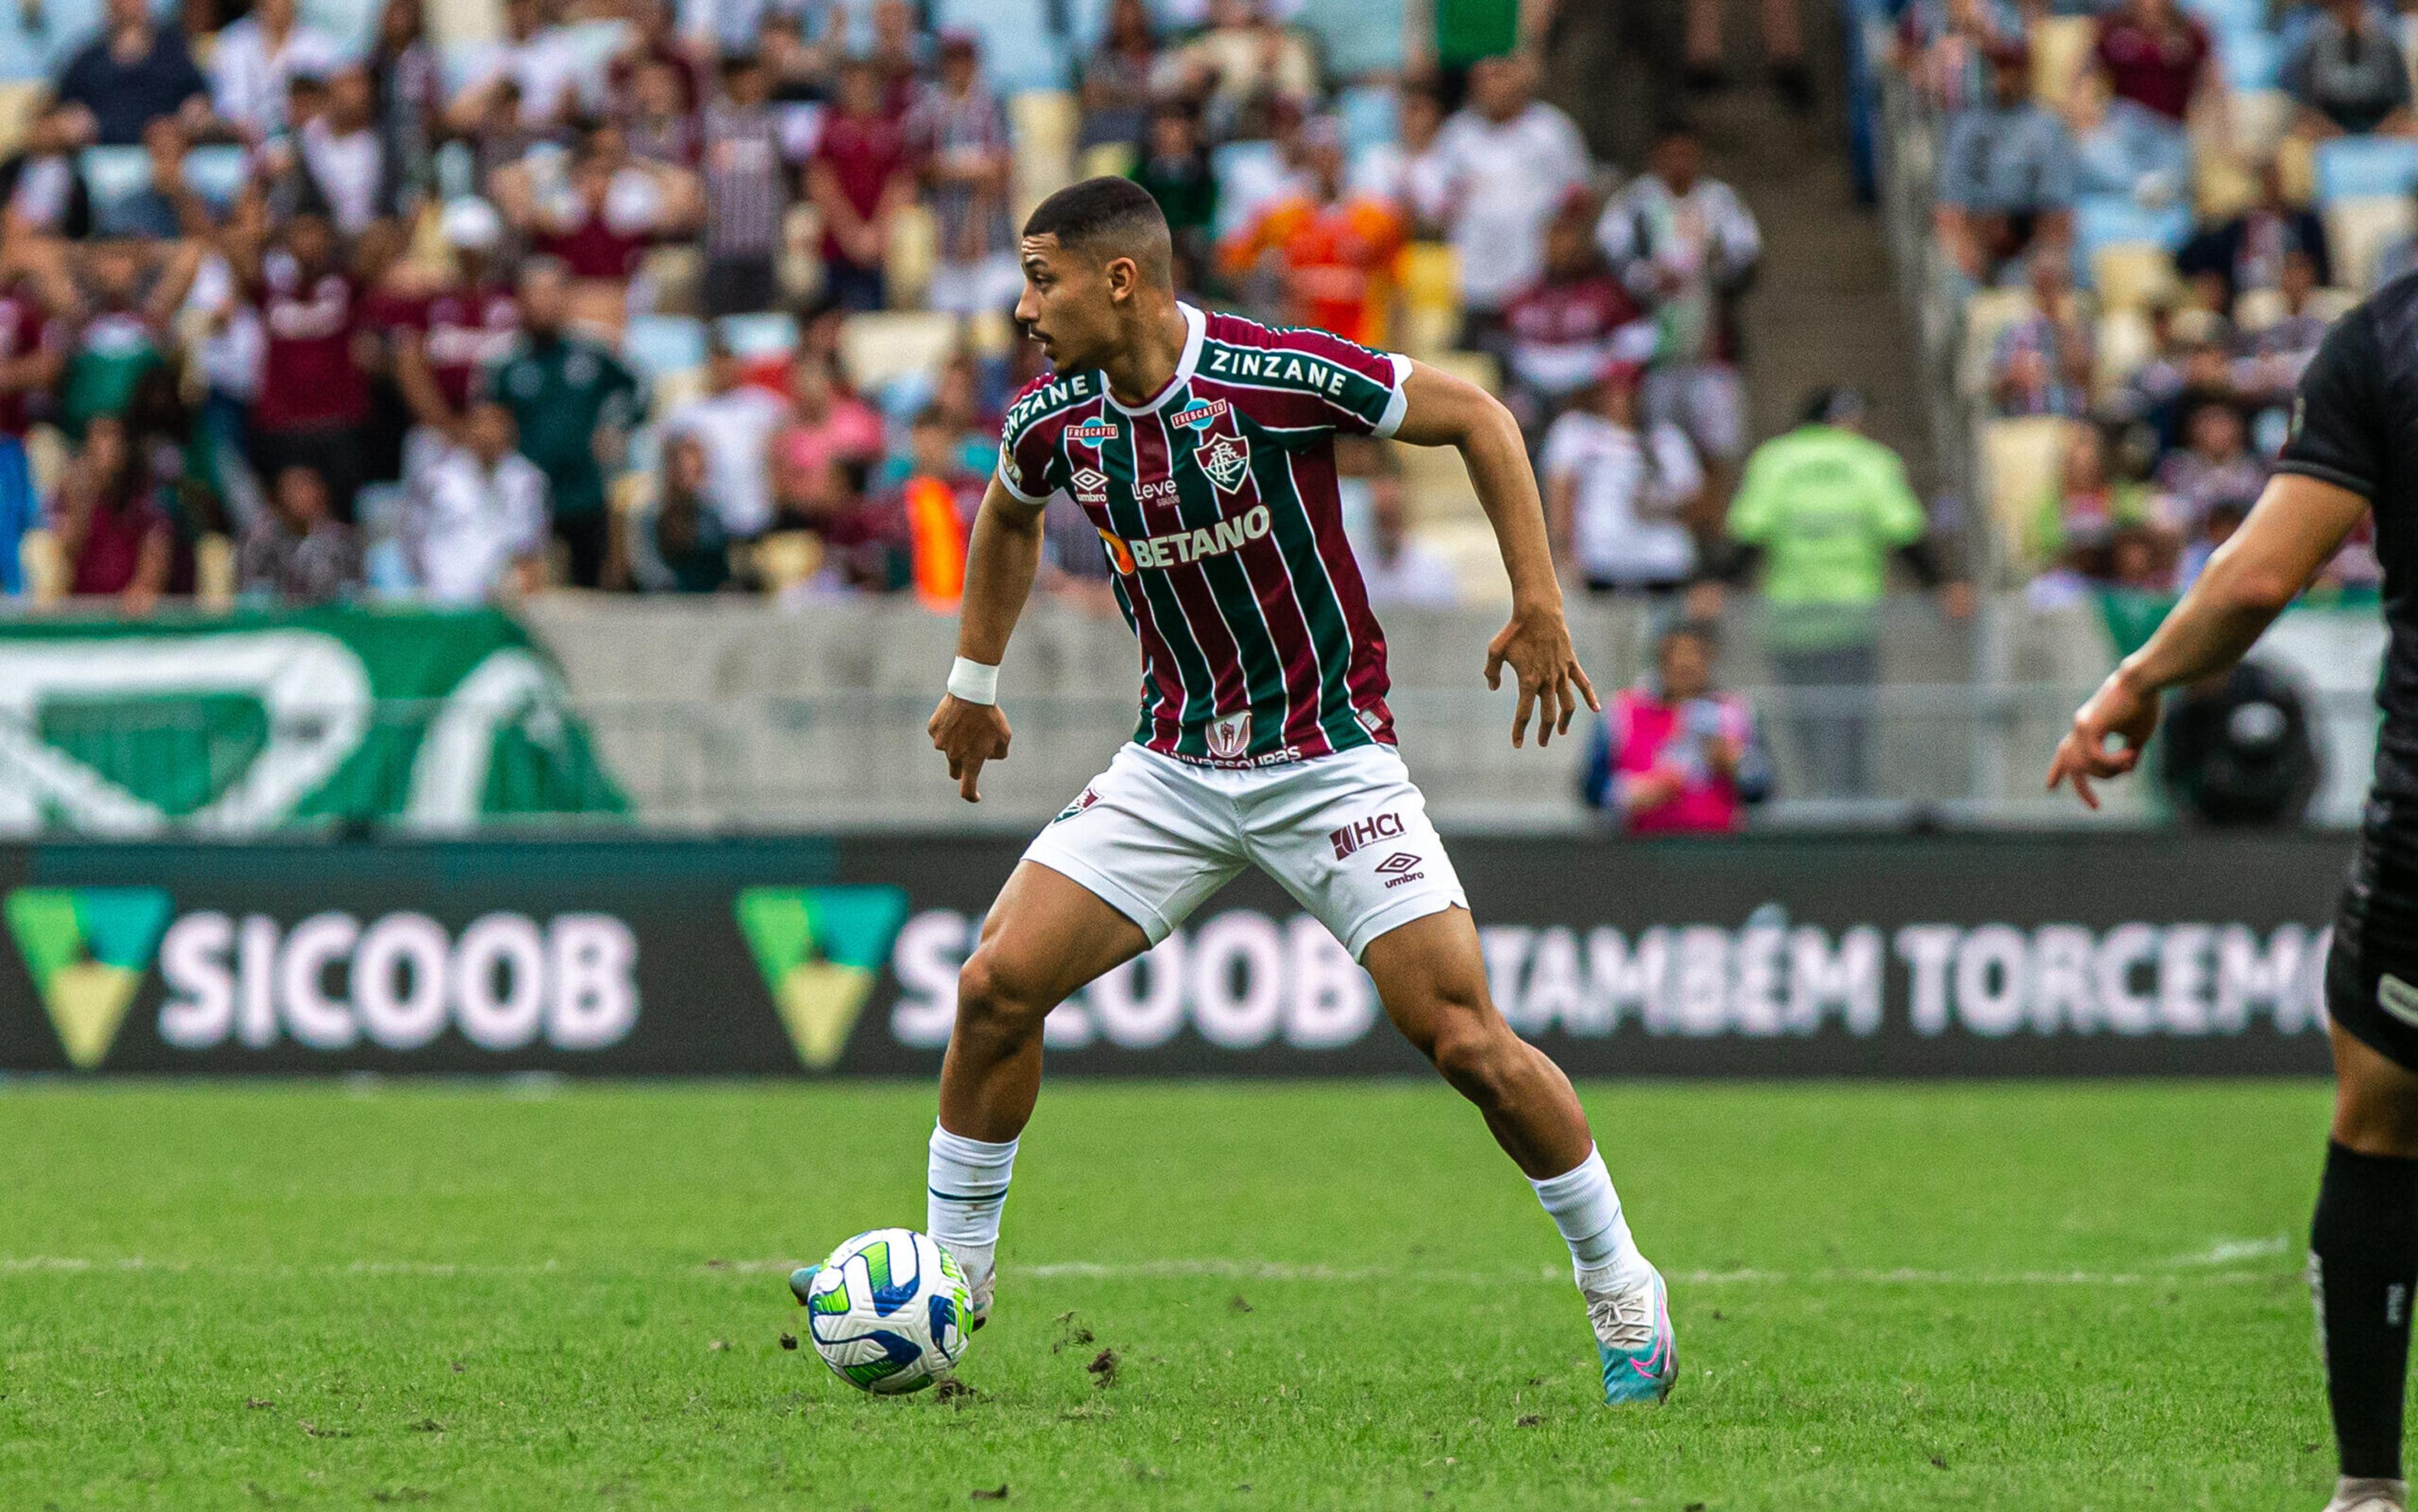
top-left (0, 833), bottom-right (2348, 1077)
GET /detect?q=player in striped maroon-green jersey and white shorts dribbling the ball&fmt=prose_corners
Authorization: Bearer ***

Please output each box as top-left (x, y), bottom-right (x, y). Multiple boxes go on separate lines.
top-left (791, 179), bottom-right (1678, 1403)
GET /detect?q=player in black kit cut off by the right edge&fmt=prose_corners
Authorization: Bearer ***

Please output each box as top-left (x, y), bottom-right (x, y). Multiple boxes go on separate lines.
top-left (2048, 278), bottom-right (2418, 1512)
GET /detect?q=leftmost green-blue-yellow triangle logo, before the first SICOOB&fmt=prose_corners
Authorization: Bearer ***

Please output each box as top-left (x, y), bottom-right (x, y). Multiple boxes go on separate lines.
top-left (5, 888), bottom-right (174, 1072)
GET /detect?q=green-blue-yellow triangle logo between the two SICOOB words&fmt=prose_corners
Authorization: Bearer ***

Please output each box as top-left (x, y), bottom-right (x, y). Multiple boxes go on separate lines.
top-left (735, 888), bottom-right (907, 1072)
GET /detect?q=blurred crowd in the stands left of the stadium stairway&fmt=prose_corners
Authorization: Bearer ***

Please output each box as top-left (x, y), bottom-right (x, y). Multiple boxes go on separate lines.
top-left (0, 0), bottom-right (1866, 628)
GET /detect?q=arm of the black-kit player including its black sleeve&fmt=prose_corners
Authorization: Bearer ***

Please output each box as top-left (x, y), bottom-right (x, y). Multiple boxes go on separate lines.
top-left (2048, 305), bottom-right (2392, 808)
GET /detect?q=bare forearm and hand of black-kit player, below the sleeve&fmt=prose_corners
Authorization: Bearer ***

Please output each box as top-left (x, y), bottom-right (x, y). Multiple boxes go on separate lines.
top-left (2048, 472), bottom-right (2367, 808)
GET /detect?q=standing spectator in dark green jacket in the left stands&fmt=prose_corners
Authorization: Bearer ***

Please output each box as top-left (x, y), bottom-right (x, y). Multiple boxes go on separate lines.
top-left (486, 256), bottom-right (643, 588)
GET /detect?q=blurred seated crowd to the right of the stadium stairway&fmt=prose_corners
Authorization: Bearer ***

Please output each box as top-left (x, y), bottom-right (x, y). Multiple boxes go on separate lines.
top-left (1896, 0), bottom-right (2418, 603)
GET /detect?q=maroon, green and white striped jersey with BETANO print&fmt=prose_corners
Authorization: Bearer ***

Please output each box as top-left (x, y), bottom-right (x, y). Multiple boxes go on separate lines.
top-left (999, 305), bottom-right (1410, 767)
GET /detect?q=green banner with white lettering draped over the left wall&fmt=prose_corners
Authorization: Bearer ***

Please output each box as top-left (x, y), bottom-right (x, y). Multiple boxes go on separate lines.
top-left (0, 610), bottom-right (628, 837)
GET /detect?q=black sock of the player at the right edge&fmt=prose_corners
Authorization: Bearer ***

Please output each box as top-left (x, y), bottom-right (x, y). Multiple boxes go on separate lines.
top-left (2309, 1144), bottom-right (2418, 1478)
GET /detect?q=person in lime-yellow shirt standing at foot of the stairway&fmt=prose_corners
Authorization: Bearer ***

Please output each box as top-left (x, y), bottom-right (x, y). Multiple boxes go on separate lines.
top-left (1729, 387), bottom-right (1973, 799)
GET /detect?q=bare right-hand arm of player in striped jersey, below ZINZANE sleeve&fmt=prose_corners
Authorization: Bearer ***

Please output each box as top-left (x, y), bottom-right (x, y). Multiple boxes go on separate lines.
top-left (1395, 363), bottom-right (1603, 745)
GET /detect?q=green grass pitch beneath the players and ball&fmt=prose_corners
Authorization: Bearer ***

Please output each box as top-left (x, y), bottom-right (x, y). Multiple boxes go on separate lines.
top-left (0, 1081), bottom-right (2334, 1512)
